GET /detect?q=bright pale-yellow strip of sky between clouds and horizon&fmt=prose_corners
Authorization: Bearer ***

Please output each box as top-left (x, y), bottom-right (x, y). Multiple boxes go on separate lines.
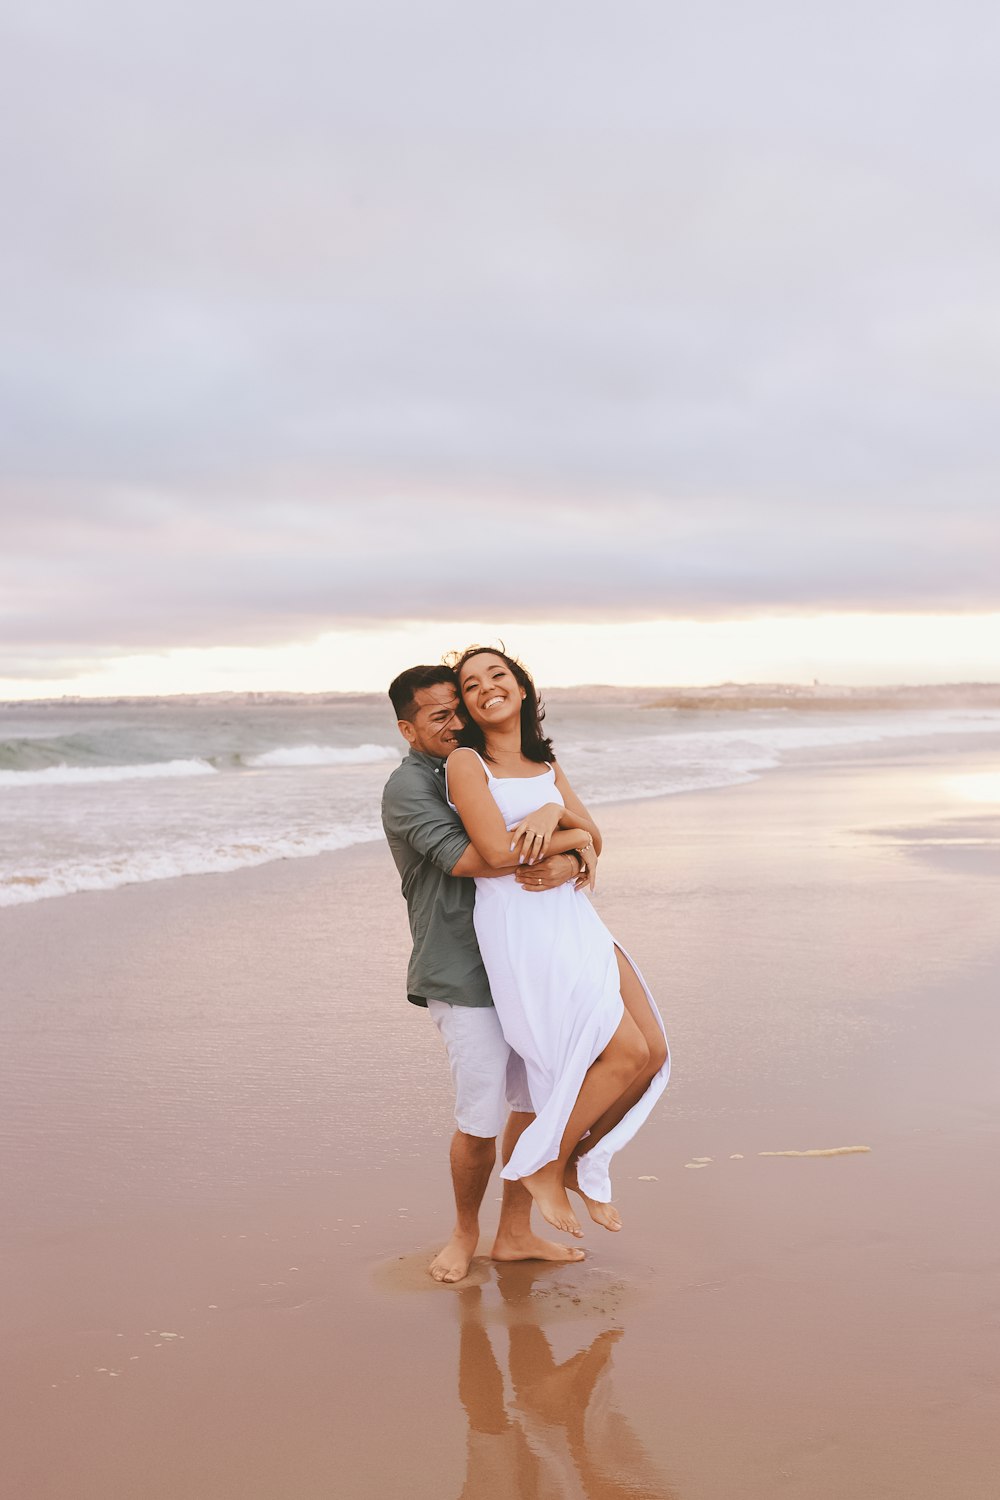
top-left (0, 614), bottom-right (1000, 698)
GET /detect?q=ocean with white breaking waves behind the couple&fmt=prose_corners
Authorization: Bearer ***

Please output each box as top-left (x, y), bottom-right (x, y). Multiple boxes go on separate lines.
top-left (0, 690), bottom-right (1000, 906)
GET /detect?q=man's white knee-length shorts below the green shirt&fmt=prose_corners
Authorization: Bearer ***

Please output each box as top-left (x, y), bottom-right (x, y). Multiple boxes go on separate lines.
top-left (427, 1001), bottom-right (532, 1139)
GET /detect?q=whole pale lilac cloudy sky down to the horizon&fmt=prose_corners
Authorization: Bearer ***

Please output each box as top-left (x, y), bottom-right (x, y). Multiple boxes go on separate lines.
top-left (0, 0), bottom-right (1000, 696)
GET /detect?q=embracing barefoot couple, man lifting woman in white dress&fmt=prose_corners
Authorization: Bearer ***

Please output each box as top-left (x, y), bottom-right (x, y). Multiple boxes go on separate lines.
top-left (382, 647), bottom-right (670, 1281)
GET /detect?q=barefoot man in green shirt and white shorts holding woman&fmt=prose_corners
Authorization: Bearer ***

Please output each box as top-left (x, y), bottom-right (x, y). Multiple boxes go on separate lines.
top-left (382, 666), bottom-right (583, 1281)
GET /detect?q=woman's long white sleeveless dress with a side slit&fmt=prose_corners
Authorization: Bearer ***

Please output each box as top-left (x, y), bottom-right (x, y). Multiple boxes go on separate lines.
top-left (449, 758), bottom-right (670, 1203)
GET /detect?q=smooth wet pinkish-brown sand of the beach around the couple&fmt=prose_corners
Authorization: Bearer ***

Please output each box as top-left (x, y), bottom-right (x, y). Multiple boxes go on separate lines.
top-left (0, 737), bottom-right (1000, 1500)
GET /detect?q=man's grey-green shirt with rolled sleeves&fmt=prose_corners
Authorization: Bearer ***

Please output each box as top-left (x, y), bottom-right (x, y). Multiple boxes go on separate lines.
top-left (382, 750), bottom-right (493, 1005)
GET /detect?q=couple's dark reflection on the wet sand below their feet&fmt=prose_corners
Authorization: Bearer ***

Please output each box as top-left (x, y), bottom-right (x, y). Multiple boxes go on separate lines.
top-left (457, 1265), bottom-right (675, 1500)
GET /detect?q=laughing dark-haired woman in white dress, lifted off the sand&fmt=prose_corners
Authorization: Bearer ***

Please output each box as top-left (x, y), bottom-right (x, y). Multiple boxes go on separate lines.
top-left (447, 647), bottom-right (670, 1236)
